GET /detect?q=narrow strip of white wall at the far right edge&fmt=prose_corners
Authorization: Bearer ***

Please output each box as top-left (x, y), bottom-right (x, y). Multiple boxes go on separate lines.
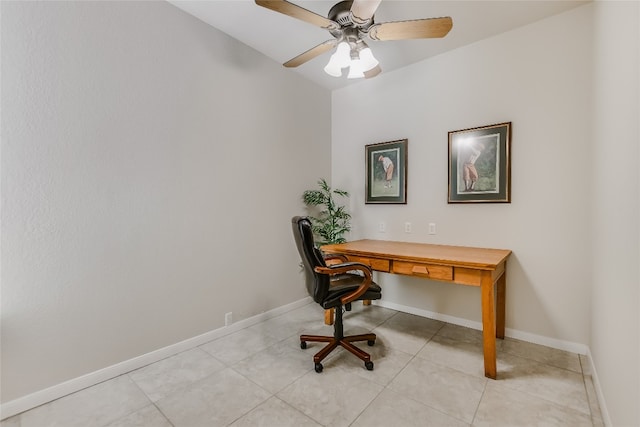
top-left (589, 2), bottom-right (640, 426)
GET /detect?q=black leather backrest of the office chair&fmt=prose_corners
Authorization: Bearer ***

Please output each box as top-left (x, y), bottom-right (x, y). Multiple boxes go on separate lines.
top-left (291, 216), bottom-right (330, 304)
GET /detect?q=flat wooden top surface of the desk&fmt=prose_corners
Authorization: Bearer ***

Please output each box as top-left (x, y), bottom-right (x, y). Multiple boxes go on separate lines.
top-left (322, 240), bottom-right (511, 268)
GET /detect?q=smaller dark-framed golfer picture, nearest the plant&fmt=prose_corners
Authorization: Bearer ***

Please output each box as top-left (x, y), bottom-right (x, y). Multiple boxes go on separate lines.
top-left (365, 139), bottom-right (408, 204)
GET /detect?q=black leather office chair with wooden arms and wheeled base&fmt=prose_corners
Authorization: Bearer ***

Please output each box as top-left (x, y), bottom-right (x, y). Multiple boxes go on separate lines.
top-left (291, 216), bottom-right (382, 373)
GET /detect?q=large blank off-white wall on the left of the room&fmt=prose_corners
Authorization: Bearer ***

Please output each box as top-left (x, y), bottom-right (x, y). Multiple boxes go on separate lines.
top-left (0, 1), bottom-right (331, 403)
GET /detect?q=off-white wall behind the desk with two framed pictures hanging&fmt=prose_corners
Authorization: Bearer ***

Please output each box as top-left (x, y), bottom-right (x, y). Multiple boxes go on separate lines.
top-left (332, 8), bottom-right (591, 349)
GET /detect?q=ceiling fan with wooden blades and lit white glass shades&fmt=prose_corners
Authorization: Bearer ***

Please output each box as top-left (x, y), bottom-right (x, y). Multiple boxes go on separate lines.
top-left (255, 0), bottom-right (453, 78)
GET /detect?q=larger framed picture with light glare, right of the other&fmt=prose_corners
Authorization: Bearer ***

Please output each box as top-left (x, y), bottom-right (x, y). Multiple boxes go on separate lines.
top-left (449, 122), bottom-right (511, 203)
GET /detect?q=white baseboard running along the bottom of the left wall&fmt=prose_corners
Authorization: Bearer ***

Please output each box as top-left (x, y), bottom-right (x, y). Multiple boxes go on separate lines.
top-left (0, 297), bottom-right (312, 420)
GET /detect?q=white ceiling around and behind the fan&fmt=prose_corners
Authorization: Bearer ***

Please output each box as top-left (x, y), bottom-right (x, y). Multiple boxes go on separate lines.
top-left (169, 0), bottom-right (586, 89)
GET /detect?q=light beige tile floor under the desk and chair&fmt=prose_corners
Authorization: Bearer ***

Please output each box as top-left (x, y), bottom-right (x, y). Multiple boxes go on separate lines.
top-left (1, 304), bottom-right (603, 427)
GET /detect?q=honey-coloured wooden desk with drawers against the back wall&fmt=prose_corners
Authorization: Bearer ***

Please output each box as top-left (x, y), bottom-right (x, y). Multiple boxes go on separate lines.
top-left (321, 240), bottom-right (511, 379)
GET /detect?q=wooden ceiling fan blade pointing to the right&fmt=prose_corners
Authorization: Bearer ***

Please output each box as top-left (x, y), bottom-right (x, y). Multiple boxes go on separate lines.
top-left (369, 17), bottom-right (453, 40)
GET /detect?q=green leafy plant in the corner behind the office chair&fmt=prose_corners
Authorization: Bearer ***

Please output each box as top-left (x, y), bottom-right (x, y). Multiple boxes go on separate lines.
top-left (302, 179), bottom-right (351, 246)
